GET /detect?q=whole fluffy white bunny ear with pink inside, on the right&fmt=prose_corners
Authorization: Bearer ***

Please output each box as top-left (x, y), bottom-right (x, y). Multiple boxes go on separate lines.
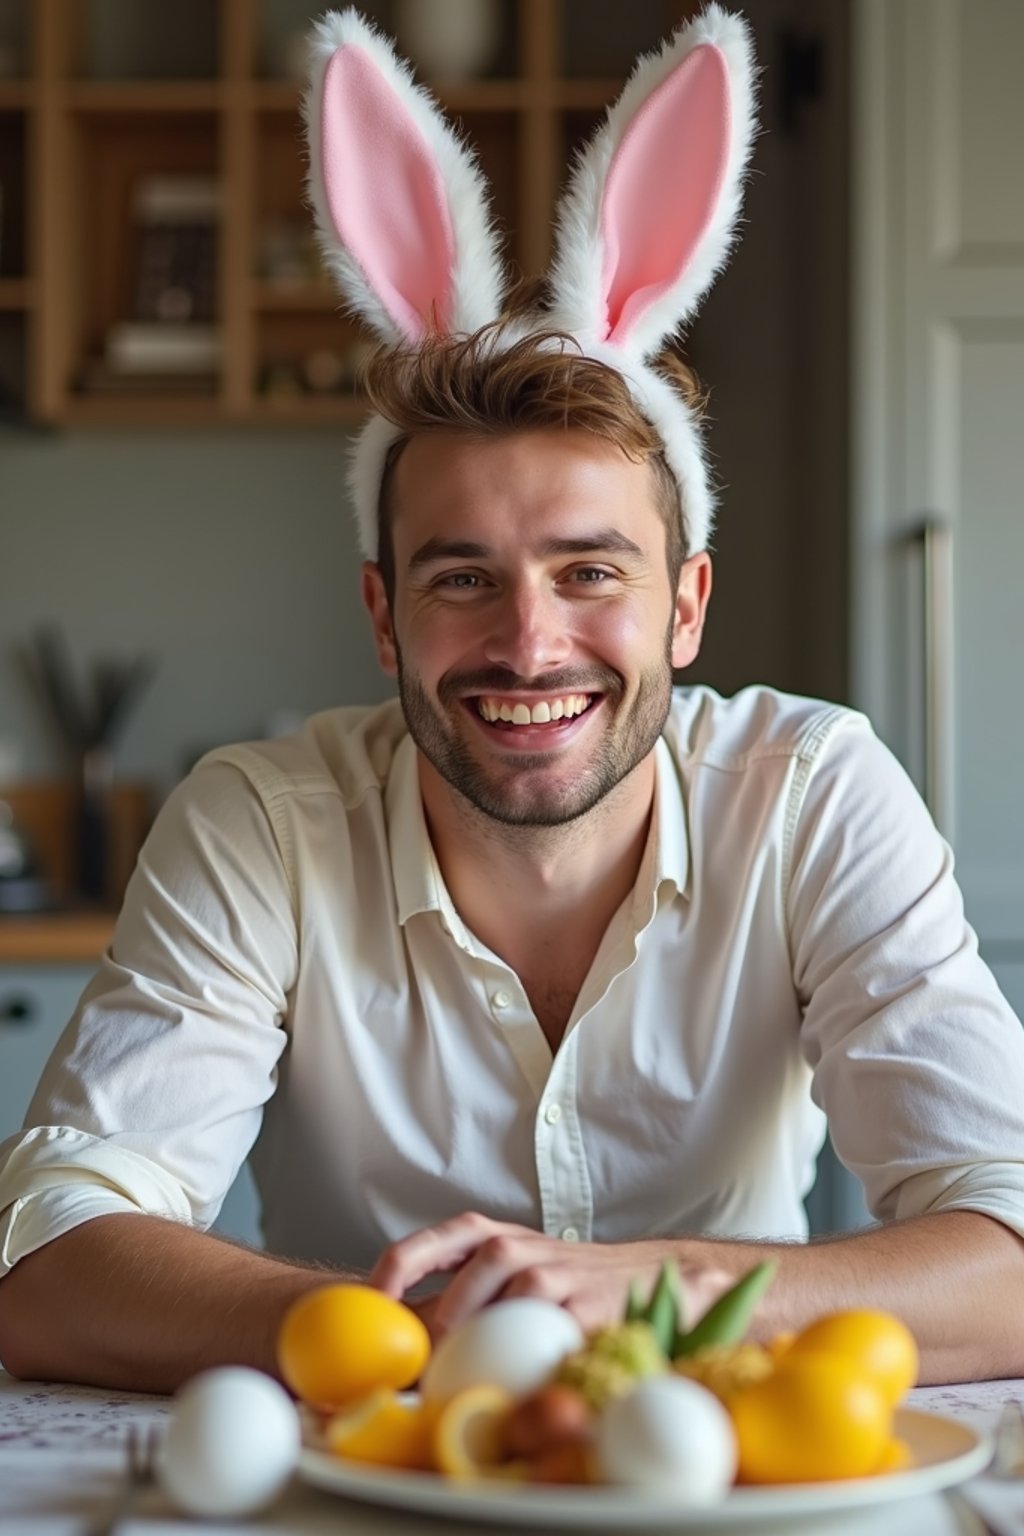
top-left (551, 5), bottom-right (754, 358)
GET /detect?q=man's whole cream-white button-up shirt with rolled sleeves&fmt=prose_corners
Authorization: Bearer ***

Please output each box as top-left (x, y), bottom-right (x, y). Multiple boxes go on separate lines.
top-left (0, 687), bottom-right (1024, 1273)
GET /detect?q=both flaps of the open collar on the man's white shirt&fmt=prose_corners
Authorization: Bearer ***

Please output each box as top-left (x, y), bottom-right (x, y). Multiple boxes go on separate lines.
top-left (385, 736), bottom-right (689, 929)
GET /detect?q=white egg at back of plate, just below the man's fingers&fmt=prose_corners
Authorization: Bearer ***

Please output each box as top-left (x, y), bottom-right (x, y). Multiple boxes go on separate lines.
top-left (421, 1296), bottom-right (583, 1401)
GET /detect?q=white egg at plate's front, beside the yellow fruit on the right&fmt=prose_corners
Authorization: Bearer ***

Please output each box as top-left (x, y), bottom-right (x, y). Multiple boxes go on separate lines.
top-left (597, 1376), bottom-right (737, 1504)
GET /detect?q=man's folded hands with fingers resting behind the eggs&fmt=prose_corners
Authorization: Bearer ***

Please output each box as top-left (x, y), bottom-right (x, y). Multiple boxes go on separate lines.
top-left (370, 1210), bottom-right (734, 1338)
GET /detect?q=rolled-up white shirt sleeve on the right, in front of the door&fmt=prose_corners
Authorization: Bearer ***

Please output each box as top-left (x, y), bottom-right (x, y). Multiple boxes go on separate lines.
top-left (786, 716), bottom-right (1024, 1235)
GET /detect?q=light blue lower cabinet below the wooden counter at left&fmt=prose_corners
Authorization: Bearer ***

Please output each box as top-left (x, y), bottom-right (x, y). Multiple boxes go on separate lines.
top-left (0, 965), bottom-right (263, 1246)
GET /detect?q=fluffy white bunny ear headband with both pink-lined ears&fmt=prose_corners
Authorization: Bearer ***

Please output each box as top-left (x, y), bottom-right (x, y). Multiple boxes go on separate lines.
top-left (306, 5), bottom-right (754, 559)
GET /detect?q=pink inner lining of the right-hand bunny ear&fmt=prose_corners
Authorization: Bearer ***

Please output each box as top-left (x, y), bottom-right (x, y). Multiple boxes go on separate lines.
top-left (600, 43), bottom-right (729, 344)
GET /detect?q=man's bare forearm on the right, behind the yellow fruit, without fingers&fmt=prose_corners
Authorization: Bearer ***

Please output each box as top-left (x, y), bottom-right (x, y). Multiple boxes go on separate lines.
top-left (676, 1210), bottom-right (1024, 1384)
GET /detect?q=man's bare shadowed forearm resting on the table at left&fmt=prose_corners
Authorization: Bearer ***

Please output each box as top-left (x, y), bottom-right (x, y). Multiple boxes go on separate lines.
top-left (0, 1213), bottom-right (363, 1392)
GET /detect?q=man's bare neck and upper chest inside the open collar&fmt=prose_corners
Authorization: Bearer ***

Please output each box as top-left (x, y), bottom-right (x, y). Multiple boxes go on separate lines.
top-left (419, 753), bottom-right (656, 977)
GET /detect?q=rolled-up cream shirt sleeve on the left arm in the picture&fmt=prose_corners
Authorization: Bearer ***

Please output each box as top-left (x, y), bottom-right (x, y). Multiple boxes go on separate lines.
top-left (0, 760), bottom-right (298, 1275)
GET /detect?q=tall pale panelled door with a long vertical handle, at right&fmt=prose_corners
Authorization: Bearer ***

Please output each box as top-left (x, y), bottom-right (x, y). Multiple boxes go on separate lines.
top-left (852, 0), bottom-right (1024, 1015)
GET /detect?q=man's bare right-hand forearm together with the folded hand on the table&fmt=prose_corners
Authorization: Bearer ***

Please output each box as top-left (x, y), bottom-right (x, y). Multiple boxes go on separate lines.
top-left (370, 1210), bottom-right (1024, 1385)
